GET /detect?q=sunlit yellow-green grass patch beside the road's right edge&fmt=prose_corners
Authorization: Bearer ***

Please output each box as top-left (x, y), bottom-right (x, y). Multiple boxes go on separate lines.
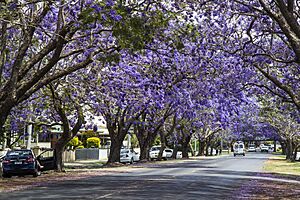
top-left (264, 155), bottom-right (300, 176)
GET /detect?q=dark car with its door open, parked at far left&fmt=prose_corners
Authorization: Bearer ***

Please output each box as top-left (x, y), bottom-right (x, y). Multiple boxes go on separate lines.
top-left (2, 149), bottom-right (54, 178)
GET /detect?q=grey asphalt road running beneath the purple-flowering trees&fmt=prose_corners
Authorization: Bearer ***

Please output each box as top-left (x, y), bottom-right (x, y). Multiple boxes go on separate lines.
top-left (0, 153), bottom-right (270, 200)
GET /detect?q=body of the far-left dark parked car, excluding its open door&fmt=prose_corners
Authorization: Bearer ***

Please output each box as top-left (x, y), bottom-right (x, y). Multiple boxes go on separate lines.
top-left (2, 149), bottom-right (41, 178)
